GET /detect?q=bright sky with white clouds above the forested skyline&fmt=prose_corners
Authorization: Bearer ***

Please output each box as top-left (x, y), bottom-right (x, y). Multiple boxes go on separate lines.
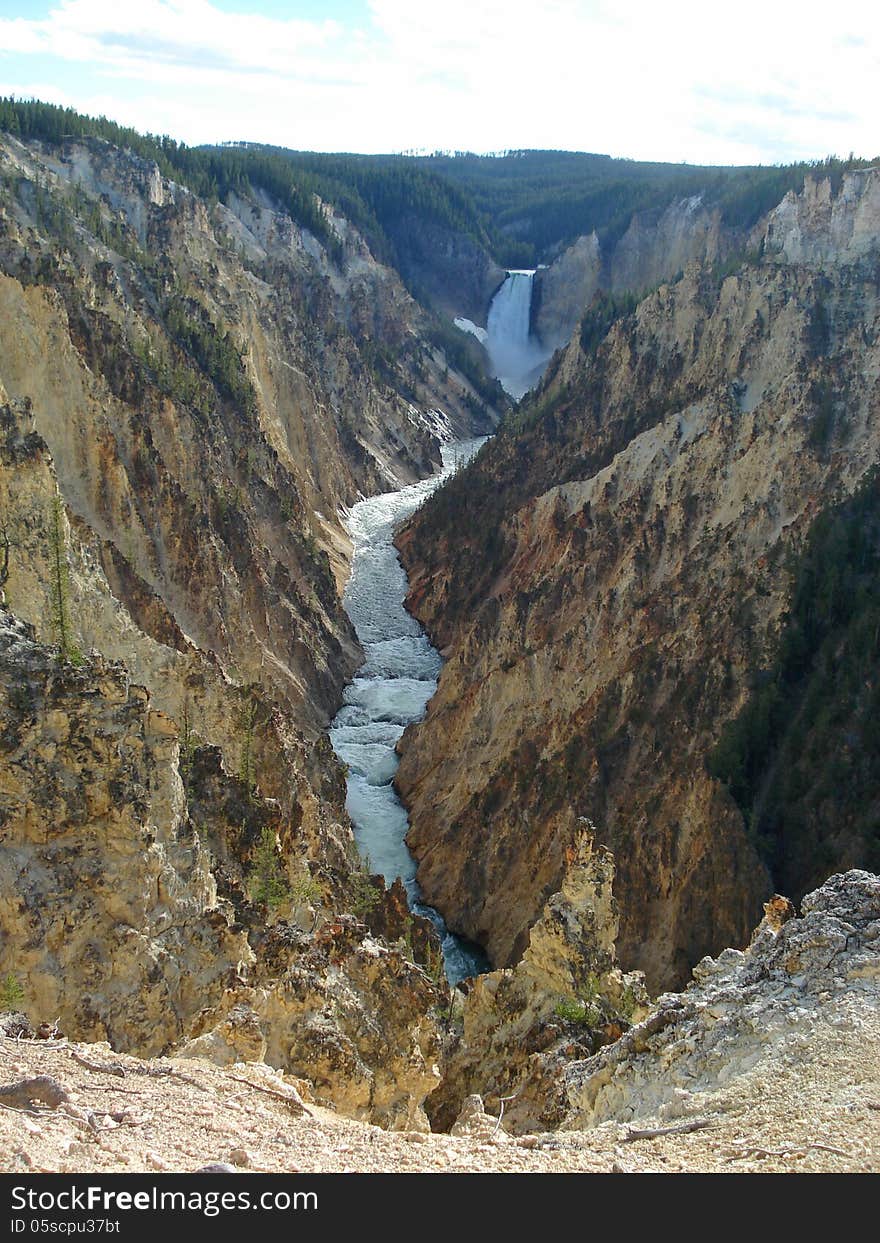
top-left (0, 0), bottom-right (880, 164)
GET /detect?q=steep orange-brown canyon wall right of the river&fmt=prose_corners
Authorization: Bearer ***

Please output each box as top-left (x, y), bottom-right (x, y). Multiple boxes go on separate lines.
top-left (396, 170), bottom-right (880, 989)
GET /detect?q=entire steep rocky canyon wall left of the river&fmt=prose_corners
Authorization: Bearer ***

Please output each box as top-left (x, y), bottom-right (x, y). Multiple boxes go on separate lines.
top-left (0, 131), bottom-right (509, 1127)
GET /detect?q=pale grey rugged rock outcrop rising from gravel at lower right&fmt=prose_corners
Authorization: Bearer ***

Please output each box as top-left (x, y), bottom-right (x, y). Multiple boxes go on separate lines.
top-left (564, 870), bottom-right (880, 1130)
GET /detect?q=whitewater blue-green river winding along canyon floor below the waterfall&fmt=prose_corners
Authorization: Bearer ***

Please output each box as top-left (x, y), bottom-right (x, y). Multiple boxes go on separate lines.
top-left (329, 440), bottom-right (488, 983)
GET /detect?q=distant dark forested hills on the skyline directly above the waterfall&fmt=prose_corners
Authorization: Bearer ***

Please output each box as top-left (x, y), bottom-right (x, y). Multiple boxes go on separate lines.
top-left (234, 144), bottom-right (868, 267)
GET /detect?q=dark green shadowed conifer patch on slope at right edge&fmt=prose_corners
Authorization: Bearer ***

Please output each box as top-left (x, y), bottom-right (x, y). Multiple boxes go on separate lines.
top-left (708, 470), bottom-right (880, 897)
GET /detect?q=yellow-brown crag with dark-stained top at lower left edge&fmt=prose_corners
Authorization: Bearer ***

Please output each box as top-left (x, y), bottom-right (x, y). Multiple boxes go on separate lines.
top-left (0, 612), bottom-right (252, 1054)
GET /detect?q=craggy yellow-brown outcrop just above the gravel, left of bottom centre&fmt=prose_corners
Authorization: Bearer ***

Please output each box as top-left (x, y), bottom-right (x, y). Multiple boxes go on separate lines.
top-left (176, 920), bottom-right (441, 1131)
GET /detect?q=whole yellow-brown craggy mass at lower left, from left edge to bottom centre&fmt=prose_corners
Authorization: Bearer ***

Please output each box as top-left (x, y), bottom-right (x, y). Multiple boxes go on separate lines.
top-left (0, 610), bottom-right (440, 1129)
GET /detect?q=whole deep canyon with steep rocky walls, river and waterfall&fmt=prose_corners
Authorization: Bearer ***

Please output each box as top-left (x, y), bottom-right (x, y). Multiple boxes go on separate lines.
top-left (0, 106), bottom-right (880, 1168)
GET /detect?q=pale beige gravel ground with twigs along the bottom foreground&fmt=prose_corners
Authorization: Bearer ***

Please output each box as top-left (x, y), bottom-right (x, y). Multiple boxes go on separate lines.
top-left (0, 1012), bottom-right (880, 1173)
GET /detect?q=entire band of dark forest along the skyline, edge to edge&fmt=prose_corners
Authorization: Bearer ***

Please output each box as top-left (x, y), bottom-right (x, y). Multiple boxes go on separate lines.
top-left (0, 97), bottom-right (869, 282)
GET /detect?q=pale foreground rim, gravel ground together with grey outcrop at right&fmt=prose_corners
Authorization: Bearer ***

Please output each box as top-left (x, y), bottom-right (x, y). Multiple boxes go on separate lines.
top-left (0, 860), bottom-right (880, 1176)
